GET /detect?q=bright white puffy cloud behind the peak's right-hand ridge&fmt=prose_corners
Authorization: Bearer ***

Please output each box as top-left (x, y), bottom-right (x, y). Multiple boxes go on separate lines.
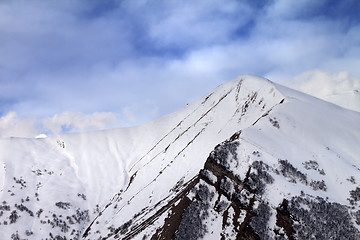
top-left (290, 70), bottom-right (360, 112)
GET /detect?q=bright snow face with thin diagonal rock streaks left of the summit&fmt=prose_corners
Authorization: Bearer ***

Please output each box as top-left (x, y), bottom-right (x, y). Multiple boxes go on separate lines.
top-left (84, 76), bottom-right (284, 238)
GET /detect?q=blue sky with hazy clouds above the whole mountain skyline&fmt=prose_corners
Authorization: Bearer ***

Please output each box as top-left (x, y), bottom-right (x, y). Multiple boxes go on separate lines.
top-left (0, 0), bottom-right (360, 137)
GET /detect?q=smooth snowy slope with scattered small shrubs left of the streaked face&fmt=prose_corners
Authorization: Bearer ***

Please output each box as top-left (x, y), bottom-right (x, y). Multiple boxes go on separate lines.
top-left (0, 105), bottom-right (197, 239)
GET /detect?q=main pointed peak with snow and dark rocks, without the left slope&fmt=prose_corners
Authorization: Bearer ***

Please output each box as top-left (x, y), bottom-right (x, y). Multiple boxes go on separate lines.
top-left (84, 76), bottom-right (360, 239)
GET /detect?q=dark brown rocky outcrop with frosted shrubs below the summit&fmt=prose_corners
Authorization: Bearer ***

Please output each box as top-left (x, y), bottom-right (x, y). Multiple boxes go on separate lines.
top-left (93, 133), bottom-right (360, 240)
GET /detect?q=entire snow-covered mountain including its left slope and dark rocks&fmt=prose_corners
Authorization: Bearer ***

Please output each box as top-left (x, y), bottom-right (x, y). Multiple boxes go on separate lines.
top-left (0, 75), bottom-right (360, 239)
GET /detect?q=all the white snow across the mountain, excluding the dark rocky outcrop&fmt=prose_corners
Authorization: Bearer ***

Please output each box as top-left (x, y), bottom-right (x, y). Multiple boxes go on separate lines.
top-left (0, 75), bottom-right (360, 239)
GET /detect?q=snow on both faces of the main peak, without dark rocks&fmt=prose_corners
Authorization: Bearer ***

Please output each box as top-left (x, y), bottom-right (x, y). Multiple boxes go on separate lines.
top-left (87, 77), bottom-right (360, 239)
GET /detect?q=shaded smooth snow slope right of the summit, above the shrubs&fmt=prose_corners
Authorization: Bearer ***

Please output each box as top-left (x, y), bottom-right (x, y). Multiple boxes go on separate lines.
top-left (241, 83), bottom-right (360, 204)
